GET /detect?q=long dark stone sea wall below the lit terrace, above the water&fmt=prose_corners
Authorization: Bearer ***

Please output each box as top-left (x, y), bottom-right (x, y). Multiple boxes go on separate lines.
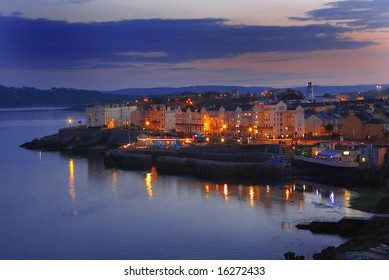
top-left (105, 144), bottom-right (286, 180)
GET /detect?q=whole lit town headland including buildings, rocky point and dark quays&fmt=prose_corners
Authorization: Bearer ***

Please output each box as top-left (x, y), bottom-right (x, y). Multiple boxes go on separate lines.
top-left (22, 82), bottom-right (389, 187)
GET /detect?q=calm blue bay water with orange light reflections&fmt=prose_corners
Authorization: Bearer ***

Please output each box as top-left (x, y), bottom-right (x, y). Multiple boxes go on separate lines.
top-left (0, 109), bottom-right (364, 259)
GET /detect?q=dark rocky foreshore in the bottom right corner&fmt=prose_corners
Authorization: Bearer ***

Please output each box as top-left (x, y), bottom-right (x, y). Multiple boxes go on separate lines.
top-left (303, 194), bottom-right (389, 260)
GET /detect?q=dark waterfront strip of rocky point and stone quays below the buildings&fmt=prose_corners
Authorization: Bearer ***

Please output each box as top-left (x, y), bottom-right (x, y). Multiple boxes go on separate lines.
top-left (21, 126), bottom-right (389, 187)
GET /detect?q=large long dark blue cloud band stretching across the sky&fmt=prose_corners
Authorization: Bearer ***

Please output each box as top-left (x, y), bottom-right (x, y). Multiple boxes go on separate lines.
top-left (0, 16), bottom-right (375, 69)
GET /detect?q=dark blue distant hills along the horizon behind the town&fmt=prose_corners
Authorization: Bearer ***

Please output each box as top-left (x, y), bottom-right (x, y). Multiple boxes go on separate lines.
top-left (0, 84), bottom-right (389, 108)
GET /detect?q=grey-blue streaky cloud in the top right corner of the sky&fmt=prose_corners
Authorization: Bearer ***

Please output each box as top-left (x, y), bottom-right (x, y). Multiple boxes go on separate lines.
top-left (291, 0), bottom-right (389, 30)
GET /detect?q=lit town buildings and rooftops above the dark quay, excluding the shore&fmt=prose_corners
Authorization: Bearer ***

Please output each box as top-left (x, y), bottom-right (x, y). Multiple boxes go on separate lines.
top-left (86, 83), bottom-right (389, 143)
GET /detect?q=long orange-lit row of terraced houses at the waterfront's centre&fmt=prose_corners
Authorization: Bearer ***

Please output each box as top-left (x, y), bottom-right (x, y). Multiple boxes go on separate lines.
top-left (138, 102), bottom-right (304, 138)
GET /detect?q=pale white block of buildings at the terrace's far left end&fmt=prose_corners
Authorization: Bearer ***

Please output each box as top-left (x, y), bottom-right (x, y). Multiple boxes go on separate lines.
top-left (85, 104), bottom-right (137, 128)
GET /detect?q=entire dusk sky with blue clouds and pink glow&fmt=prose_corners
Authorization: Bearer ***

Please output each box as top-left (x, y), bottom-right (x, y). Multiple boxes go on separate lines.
top-left (0, 0), bottom-right (389, 90)
